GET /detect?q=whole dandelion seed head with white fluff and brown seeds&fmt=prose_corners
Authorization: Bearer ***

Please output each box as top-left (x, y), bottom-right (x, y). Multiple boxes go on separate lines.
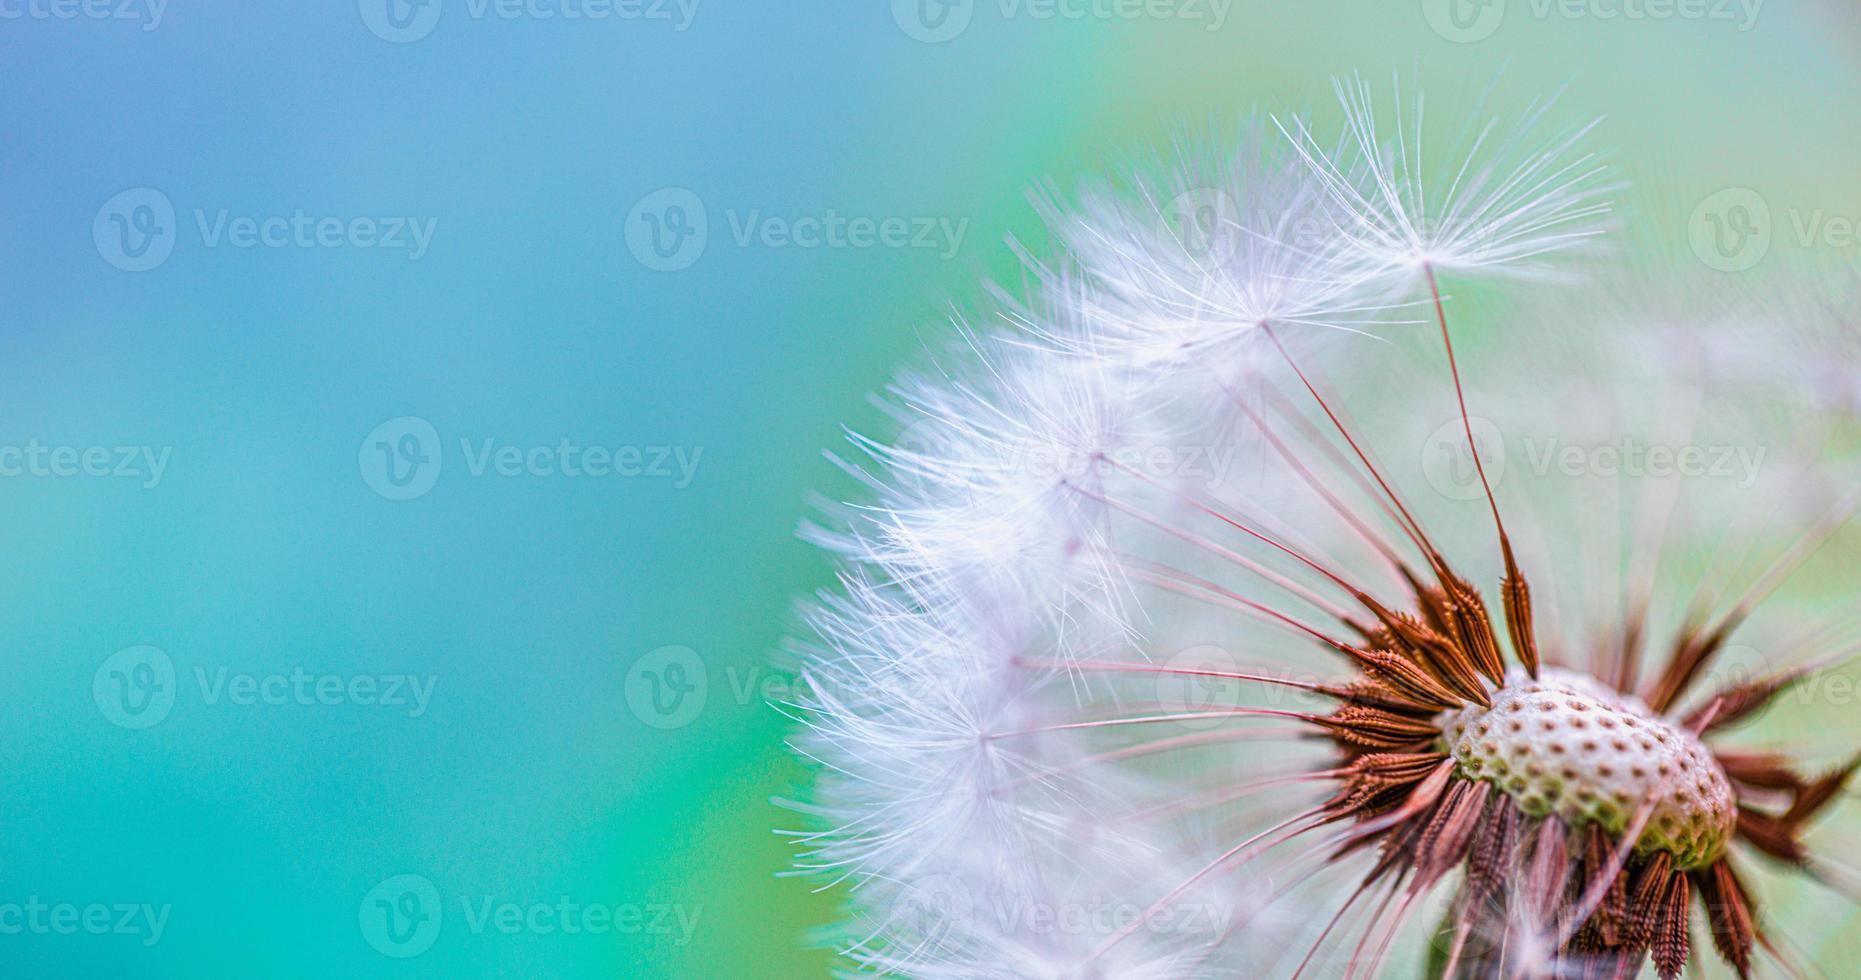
top-left (789, 86), bottom-right (1861, 980)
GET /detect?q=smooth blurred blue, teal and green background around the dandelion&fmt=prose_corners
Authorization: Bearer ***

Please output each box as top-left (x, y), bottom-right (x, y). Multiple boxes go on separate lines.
top-left (0, 0), bottom-right (1861, 976)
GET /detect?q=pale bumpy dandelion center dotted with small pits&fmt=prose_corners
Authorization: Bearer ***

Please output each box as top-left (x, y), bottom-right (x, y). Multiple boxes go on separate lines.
top-left (1440, 668), bottom-right (1736, 868)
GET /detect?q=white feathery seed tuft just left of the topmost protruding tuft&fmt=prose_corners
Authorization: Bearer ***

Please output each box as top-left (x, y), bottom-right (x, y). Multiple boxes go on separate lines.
top-left (1029, 123), bottom-right (1385, 383)
